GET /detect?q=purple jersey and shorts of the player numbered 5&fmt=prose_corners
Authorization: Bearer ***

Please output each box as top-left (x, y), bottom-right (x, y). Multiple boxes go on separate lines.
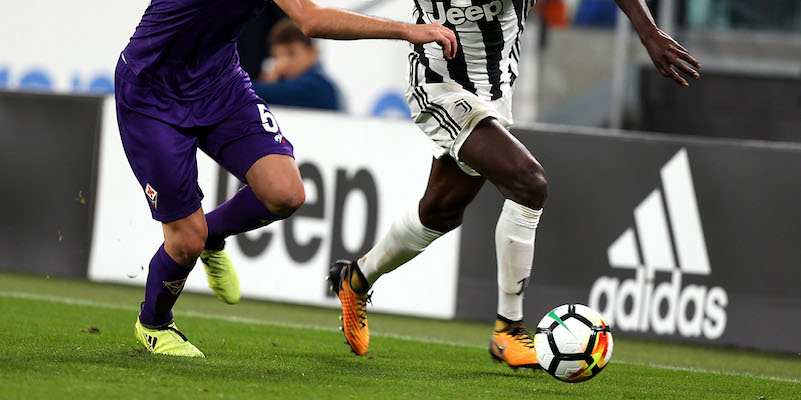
top-left (115, 0), bottom-right (293, 222)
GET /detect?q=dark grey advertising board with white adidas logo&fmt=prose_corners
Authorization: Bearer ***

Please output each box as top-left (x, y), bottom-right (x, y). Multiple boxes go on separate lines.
top-left (456, 127), bottom-right (801, 352)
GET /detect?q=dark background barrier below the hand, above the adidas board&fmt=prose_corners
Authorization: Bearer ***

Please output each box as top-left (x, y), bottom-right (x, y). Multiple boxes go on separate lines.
top-left (638, 62), bottom-right (801, 142)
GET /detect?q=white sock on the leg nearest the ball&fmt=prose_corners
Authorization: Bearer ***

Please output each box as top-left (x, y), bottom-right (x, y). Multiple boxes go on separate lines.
top-left (495, 199), bottom-right (542, 321)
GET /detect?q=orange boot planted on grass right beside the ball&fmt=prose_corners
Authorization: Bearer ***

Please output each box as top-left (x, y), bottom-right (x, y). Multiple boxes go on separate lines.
top-left (490, 316), bottom-right (540, 370)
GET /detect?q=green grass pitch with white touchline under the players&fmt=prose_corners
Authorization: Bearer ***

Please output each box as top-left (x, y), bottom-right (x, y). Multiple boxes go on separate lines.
top-left (0, 274), bottom-right (801, 399)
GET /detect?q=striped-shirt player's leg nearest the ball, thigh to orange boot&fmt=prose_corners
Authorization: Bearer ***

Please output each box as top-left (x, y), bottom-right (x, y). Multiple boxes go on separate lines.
top-left (459, 118), bottom-right (548, 369)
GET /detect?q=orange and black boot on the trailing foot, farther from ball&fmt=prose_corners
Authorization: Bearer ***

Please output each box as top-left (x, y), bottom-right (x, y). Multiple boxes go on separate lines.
top-left (328, 260), bottom-right (370, 356)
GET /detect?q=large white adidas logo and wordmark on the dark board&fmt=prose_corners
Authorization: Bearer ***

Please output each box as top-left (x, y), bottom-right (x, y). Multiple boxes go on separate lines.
top-left (589, 149), bottom-right (729, 339)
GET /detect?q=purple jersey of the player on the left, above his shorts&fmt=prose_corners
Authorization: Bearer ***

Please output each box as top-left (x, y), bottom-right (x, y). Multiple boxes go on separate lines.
top-left (122, 0), bottom-right (266, 100)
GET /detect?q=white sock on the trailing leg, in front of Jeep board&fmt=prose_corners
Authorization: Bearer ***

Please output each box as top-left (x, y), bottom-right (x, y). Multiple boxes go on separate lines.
top-left (358, 205), bottom-right (442, 286)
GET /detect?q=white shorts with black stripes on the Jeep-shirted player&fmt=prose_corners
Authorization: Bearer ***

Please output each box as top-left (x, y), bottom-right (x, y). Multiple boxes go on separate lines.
top-left (406, 82), bottom-right (512, 176)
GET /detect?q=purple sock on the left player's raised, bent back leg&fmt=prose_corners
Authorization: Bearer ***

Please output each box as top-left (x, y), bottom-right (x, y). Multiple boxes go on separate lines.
top-left (206, 186), bottom-right (284, 250)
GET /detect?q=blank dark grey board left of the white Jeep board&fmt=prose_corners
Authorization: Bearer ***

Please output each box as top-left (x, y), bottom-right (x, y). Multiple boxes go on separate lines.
top-left (0, 91), bottom-right (102, 277)
